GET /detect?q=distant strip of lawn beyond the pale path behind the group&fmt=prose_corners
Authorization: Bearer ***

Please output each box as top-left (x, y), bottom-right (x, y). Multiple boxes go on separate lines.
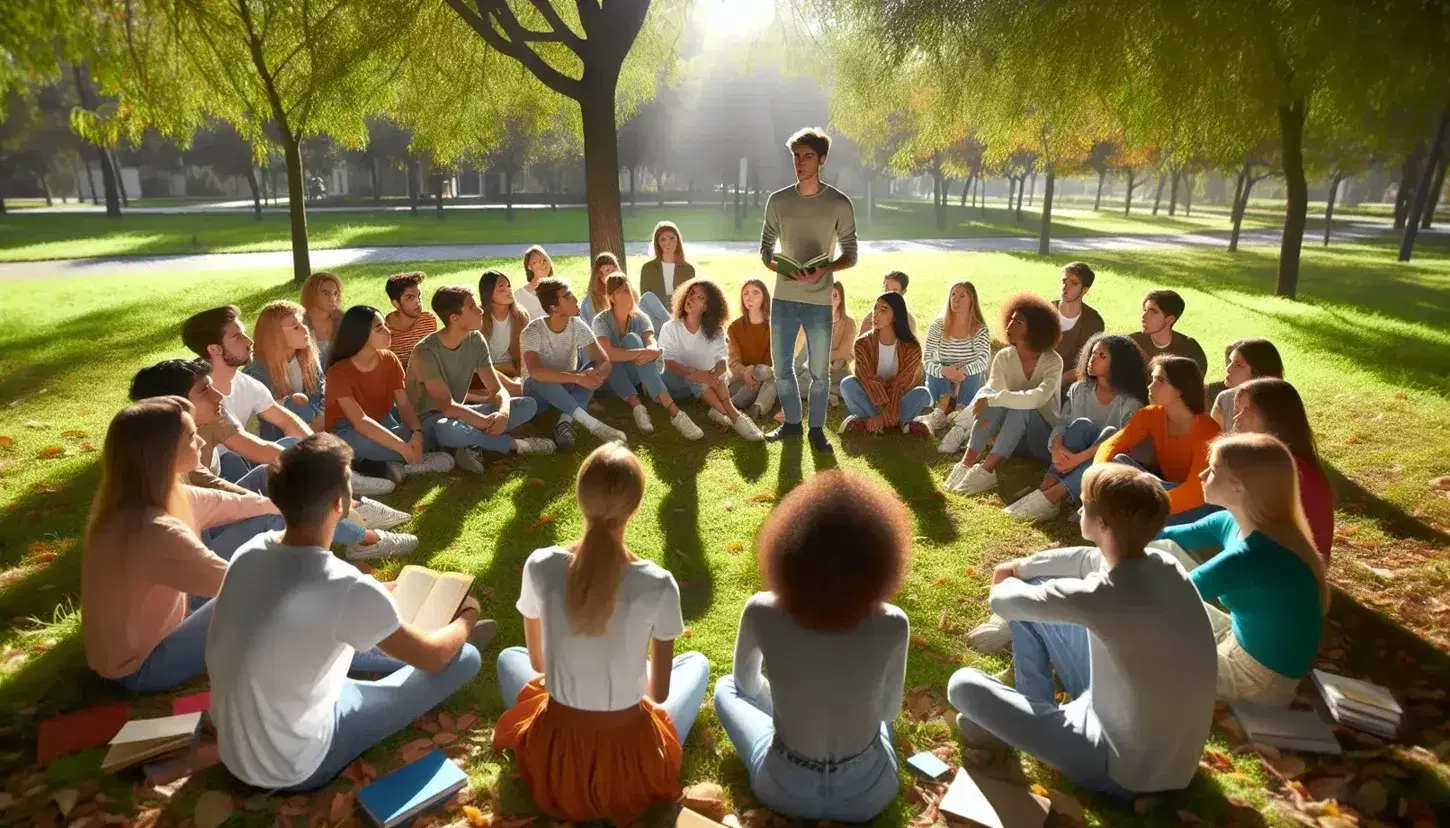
top-left (0, 200), bottom-right (1316, 261)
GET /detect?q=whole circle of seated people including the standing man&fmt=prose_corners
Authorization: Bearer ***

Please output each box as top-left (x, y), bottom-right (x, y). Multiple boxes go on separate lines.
top-left (83, 131), bottom-right (1333, 825)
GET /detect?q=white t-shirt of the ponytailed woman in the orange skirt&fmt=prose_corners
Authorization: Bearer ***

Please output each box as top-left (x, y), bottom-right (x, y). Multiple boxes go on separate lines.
top-left (516, 547), bottom-right (684, 711)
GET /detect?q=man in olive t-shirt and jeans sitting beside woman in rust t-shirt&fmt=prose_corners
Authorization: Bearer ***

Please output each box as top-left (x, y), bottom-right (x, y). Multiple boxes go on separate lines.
top-left (407, 284), bottom-right (554, 474)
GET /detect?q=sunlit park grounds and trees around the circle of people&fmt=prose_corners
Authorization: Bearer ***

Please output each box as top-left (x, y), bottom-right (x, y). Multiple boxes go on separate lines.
top-left (0, 0), bottom-right (1450, 828)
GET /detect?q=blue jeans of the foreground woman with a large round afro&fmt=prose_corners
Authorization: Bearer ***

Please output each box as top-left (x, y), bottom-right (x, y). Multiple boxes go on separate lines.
top-left (715, 676), bottom-right (900, 822)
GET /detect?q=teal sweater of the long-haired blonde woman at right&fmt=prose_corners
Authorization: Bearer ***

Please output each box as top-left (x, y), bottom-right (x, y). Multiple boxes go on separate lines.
top-left (1159, 510), bottom-right (1324, 679)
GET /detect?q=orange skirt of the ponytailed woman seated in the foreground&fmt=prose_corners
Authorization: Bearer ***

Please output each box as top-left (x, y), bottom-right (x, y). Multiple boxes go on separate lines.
top-left (493, 677), bottom-right (684, 825)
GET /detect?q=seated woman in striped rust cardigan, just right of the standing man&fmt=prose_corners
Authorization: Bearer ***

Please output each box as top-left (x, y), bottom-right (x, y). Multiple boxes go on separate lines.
top-left (841, 293), bottom-right (931, 436)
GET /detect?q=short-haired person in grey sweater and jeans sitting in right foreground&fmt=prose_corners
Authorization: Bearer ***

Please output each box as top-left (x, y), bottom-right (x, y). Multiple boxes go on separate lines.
top-left (947, 464), bottom-right (1218, 798)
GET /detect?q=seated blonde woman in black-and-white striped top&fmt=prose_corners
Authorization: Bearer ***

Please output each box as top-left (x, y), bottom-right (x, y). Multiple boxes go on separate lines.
top-left (921, 281), bottom-right (992, 432)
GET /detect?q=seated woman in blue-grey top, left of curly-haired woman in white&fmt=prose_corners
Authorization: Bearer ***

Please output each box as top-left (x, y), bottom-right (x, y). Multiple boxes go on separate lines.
top-left (590, 273), bottom-right (705, 439)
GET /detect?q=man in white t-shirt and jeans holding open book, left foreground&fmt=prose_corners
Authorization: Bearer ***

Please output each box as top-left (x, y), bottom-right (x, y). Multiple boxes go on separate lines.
top-left (206, 434), bottom-right (496, 792)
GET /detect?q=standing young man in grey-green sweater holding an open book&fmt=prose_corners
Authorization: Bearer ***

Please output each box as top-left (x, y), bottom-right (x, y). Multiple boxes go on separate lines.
top-left (760, 128), bottom-right (856, 452)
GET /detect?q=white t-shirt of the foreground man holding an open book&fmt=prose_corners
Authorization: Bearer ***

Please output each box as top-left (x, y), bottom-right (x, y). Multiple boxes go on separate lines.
top-left (206, 534), bottom-right (402, 789)
